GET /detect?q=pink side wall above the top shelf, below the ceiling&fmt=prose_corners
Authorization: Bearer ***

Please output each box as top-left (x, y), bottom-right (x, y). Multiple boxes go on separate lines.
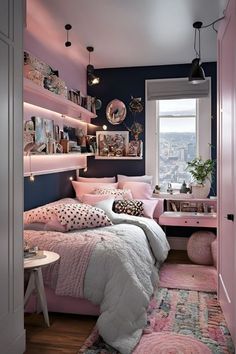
top-left (24, 30), bottom-right (87, 95)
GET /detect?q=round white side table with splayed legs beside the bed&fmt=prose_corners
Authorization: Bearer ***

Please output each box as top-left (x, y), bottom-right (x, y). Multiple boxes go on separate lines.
top-left (24, 251), bottom-right (60, 327)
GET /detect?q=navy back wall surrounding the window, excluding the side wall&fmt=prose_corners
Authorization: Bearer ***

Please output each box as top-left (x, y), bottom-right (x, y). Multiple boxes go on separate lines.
top-left (86, 62), bottom-right (217, 194)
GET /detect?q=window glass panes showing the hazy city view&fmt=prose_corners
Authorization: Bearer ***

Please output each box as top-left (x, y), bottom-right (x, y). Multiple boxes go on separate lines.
top-left (158, 99), bottom-right (197, 191)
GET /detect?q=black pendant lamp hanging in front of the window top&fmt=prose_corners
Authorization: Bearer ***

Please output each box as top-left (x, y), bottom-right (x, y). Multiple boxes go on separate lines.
top-left (188, 21), bottom-right (205, 84)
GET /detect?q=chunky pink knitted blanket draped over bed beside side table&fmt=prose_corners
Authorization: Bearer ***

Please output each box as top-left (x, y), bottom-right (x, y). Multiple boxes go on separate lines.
top-left (24, 230), bottom-right (113, 298)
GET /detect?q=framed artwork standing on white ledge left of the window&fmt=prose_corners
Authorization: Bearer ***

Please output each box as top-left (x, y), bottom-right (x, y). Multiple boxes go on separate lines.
top-left (96, 131), bottom-right (129, 157)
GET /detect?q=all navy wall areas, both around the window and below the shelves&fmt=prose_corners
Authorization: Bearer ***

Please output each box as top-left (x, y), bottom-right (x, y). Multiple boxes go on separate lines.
top-left (25, 63), bottom-right (217, 210)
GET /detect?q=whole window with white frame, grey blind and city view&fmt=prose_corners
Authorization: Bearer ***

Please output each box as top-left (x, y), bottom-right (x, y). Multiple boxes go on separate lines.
top-left (145, 78), bottom-right (211, 191)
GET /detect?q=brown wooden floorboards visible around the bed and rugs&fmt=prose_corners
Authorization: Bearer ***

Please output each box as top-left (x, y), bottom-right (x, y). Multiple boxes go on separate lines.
top-left (25, 251), bottom-right (191, 354)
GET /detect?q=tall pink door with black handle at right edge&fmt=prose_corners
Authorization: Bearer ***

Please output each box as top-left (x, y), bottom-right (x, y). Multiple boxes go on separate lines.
top-left (218, 0), bottom-right (236, 342)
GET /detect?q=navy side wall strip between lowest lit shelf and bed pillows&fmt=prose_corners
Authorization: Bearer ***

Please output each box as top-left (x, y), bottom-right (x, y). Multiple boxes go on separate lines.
top-left (24, 171), bottom-right (76, 210)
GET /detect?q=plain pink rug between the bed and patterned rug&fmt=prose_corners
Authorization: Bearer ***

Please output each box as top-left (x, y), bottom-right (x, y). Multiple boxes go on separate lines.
top-left (159, 263), bottom-right (217, 292)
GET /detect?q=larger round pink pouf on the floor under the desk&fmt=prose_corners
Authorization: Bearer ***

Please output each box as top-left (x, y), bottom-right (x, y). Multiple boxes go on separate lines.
top-left (187, 230), bottom-right (216, 265)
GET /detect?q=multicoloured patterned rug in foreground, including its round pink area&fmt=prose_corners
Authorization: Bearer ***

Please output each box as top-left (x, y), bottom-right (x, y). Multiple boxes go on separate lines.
top-left (78, 288), bottom-right (235, 354)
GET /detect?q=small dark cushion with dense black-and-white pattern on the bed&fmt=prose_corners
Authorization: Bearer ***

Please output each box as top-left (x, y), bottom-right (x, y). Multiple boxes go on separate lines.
top-left (112, 200), bottom-right (144, 216)
